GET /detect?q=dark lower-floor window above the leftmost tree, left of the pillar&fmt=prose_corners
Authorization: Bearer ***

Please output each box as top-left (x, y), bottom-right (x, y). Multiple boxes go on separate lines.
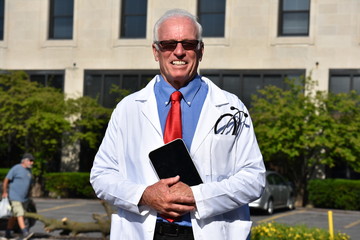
top-left (26, 71), bottom-right (64, 92)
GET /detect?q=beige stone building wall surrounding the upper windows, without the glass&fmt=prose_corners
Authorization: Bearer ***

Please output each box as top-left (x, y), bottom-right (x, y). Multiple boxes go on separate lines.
top-left (0, 0), bottom-right (360, 96)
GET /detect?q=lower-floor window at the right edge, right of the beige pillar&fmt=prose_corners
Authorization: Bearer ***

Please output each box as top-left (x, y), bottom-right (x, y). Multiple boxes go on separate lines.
top-left (329, 69), bottom-right (360, 93)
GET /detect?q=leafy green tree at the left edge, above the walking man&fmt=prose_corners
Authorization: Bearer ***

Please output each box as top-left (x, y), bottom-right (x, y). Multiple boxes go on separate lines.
top-left (0, 71), bottom-right (70, 173)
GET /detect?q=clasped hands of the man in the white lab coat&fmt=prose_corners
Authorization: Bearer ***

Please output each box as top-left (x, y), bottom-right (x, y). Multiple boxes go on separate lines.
top-left (140, 176), bottom-right (195, 218)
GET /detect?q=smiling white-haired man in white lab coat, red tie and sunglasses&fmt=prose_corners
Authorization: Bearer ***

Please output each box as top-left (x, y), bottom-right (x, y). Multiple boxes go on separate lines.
top-left (90, 9), bottom-right (265, 240)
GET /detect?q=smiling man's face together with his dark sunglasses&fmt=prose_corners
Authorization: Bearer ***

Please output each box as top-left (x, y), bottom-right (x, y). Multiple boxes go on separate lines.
top-left (153, 14), bottom-right (204, 89)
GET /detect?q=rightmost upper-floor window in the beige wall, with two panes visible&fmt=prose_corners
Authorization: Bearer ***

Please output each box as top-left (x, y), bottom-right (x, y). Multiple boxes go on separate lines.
top-left (278, 0), bottom-right (310, 36)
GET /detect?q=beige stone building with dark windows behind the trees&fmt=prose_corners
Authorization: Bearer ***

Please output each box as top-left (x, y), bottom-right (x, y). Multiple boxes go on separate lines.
top-left (0, 0), bottom-right (360, 169)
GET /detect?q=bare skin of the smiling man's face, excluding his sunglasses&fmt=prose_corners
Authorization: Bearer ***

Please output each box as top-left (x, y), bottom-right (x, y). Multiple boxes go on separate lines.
top-left (153, 17), bottom-right (204, 89)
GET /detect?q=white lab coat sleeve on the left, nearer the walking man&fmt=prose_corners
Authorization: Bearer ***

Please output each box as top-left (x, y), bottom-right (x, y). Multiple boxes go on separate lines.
top-left (90, 104), bottom-right (148, 215)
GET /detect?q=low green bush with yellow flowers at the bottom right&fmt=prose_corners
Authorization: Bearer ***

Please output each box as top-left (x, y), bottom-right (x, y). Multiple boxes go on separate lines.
top-left (251, 222), bottom-right (350, 240)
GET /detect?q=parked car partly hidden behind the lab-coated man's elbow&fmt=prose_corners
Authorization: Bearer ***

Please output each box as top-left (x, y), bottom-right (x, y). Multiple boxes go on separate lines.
top-left (249, 171), bottom-right (295, 215)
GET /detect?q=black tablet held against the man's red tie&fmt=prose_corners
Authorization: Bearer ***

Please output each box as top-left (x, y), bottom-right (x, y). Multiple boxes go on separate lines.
top-left (149, 139), bottom-right (202, 186)
